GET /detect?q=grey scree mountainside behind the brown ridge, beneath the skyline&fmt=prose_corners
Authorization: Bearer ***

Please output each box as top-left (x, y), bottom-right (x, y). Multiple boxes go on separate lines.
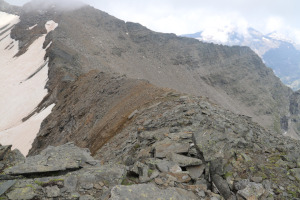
top-left (14, 3), bottom-right (292, 139)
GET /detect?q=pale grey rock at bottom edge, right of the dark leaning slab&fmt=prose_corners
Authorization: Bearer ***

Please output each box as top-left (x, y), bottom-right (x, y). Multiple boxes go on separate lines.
top-left (237, 182), bottom-right (265, 199)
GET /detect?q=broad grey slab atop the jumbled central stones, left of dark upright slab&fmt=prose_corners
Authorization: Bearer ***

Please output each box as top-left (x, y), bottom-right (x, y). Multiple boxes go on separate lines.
top-left (155, 141), bottom-right (190, 158)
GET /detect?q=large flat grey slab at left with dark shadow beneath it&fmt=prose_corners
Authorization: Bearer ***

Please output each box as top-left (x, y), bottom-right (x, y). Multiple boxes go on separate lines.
top-left (5, 143), bottom-right (97, 175)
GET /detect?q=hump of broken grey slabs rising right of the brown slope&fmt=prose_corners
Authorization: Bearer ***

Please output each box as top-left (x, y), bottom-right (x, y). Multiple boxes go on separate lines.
top-left (96, 93), bottom-right (300, 199)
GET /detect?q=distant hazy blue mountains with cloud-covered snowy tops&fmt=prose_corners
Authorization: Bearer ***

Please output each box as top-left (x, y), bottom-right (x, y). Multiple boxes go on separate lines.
top-left (183, 27), bottom-right (300, 90)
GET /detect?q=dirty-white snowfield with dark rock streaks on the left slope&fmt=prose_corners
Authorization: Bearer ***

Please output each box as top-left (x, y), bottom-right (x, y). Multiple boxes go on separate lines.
top-left (0, 12), bottom-right (57, 155)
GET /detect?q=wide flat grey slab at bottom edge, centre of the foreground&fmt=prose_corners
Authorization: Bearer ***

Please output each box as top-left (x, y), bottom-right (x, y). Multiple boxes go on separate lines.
top-left (110, 184), bottom-right (198, 200)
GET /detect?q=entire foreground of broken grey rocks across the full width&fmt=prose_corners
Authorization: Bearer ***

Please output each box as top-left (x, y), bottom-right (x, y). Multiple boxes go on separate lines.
top-left (0, 92), bottom-right (300, 200)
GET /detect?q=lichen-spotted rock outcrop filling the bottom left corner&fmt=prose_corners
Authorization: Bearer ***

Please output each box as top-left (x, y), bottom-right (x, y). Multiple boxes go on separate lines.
top-left (0, 143), bottom-right (126, 200)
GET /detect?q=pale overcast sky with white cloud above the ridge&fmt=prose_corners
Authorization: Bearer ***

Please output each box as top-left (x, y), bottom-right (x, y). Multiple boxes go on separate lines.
top-left (6, 0), bottom-right (300, 44)
